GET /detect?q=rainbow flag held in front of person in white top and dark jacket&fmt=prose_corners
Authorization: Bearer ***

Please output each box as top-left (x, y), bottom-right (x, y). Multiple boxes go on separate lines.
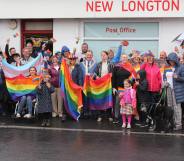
top-left (83, 74), bottom-right (113, 110)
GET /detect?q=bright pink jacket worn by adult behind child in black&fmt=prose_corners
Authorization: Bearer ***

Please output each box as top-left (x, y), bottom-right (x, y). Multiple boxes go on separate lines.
top-left (141, 63), bottom-right (162, 92)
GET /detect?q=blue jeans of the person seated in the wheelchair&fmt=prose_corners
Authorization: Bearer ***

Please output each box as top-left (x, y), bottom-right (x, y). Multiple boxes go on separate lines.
top-left (17, 96), bottom-right (33, 114)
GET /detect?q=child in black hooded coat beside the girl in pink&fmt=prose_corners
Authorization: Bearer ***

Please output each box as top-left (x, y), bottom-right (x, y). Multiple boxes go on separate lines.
top-left (135, 70), bottom-right (151, 127)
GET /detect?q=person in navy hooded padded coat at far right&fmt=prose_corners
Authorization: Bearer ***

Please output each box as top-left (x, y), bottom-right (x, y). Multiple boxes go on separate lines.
top-left (164, 53), bottom-right (184, 130)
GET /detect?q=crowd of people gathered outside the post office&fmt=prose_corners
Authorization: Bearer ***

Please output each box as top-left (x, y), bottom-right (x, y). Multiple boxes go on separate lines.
top-left (0, 39), bottom-right (184, 130)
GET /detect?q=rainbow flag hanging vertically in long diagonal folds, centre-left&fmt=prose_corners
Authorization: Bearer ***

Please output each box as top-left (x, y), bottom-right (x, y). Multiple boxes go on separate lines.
top-left (60, 60), bottom-right (83, 120)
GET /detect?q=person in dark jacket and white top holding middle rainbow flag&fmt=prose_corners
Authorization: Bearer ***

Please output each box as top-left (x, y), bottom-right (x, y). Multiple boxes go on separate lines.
top-left (95, 51), bottom-right (113, 122)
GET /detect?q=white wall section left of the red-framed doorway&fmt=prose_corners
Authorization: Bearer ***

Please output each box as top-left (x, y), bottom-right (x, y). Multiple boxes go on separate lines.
top-left (0, 20), bottom-right (21, 53)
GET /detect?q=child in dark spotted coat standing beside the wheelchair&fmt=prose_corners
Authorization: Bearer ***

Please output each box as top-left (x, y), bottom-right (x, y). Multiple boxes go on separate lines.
top-left (37, 74), bottom-right (54, 126)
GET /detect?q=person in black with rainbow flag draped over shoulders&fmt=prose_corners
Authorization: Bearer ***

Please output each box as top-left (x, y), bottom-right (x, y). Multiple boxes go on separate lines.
top-left (112, 54), bottom-right (136, 123)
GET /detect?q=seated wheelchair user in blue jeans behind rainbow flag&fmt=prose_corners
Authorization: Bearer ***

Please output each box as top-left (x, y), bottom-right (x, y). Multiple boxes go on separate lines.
top-left (16, 67), bottom-right (37, 119)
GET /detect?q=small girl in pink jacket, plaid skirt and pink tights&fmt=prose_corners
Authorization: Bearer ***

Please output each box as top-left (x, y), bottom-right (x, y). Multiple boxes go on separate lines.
top-left (119, 79), bottom-right (136, 129)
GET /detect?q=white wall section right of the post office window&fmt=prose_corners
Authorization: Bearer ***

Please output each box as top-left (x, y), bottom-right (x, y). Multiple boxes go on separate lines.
top-left (159, 18), bottom-right (184, 53)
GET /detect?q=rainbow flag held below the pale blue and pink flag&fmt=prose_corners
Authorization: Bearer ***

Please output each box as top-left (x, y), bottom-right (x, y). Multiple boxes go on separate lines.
top-left (6, 75), bottom-right (39, 101)
